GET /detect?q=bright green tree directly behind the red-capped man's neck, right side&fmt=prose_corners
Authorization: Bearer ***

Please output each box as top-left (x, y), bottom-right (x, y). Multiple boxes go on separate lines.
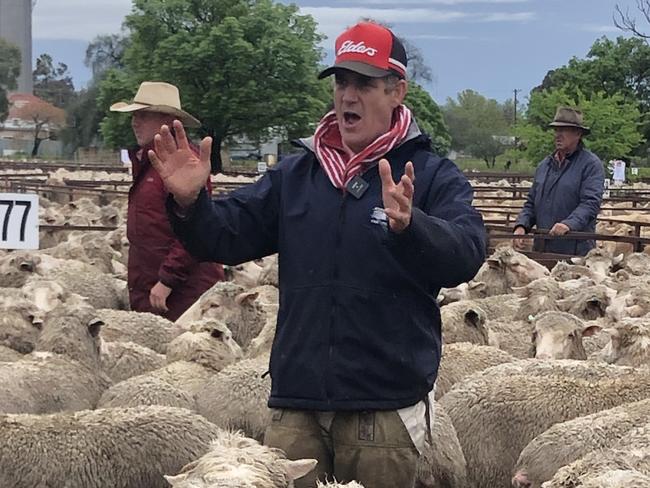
top-left (404, 82), bottom-right (451, 156)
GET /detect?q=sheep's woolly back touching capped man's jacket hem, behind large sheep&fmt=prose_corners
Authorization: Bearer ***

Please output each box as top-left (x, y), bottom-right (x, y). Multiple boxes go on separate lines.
top-left (435, 342), bottom-right (516, 400)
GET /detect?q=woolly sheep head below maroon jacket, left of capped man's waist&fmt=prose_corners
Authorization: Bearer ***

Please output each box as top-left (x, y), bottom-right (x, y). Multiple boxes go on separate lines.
top-left (167, 319), bottom-right (243, 371)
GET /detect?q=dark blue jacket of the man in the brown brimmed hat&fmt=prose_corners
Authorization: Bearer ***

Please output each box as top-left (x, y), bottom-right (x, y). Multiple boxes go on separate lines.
top-left (515, 148), bottom-right (605, 256)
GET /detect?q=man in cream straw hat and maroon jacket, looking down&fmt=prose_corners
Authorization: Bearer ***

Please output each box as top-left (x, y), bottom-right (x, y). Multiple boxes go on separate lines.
top-left (110, 81), bottom-right (224, 321)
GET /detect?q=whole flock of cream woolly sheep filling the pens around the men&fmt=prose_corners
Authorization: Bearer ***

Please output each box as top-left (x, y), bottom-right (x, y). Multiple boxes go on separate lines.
top-left (0, 167), bottom-right (650, 488)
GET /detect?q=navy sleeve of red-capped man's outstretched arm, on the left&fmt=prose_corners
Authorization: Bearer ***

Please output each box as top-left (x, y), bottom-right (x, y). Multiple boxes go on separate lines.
top-left (167, 166), bottom-right (280, 265)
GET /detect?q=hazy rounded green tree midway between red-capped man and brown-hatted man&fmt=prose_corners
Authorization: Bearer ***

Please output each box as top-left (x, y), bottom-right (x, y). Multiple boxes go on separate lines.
top-left (443, 90), bottom-right (511, 168)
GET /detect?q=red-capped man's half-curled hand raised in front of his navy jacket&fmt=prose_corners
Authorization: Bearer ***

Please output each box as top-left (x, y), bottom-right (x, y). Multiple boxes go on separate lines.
top-left (379, 159), bottom-right (415, 233)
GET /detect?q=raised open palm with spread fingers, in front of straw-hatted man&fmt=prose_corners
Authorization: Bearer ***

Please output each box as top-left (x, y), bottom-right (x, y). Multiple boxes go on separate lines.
top-left (148, 120), bottom-right (212, 208)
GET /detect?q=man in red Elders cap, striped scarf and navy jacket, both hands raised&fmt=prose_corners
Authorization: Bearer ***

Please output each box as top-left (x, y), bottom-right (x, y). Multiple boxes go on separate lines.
top-left (144, 23), bottom-right (485, 488)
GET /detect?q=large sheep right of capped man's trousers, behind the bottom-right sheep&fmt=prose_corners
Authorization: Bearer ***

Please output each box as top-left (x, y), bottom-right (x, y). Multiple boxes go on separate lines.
top-left (440, 360), bottom-right (650, 488)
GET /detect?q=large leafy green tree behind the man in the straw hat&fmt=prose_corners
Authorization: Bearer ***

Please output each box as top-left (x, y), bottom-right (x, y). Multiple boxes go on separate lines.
top-left (100, 0), bottom-right (331, 173)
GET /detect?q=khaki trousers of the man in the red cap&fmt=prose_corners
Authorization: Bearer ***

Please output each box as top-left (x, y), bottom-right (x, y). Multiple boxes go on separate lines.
top-left (264, 409), bottom-right (419, 488)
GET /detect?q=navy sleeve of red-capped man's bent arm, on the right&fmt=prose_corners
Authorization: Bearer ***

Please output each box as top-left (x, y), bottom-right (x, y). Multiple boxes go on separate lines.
top-left (388, 159), bottom-right (486, 287)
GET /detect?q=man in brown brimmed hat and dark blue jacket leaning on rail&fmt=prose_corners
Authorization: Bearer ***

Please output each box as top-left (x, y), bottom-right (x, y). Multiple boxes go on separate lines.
top-left (514, 107), bottom-right (605, 256)
